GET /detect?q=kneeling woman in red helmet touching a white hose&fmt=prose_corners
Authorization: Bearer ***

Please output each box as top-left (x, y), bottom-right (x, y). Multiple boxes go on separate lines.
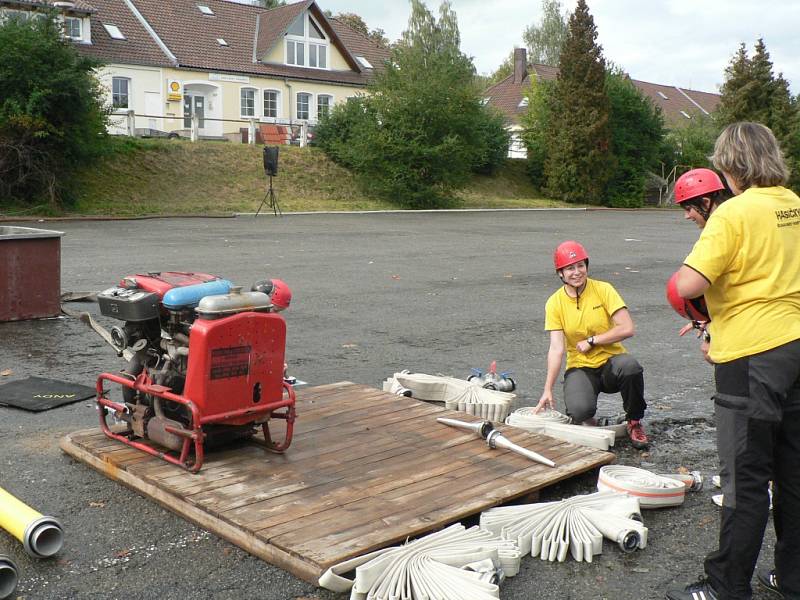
top-left (536, 241), bottom-right (648, 448)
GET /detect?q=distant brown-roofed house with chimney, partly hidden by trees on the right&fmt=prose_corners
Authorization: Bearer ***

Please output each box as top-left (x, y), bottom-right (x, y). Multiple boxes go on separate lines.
top-left (484, 48), bottom-right (719, 158)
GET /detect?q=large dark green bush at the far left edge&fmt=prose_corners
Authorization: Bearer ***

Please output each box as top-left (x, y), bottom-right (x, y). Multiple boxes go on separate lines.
top-left (0, 14), bottom-right (108, 207)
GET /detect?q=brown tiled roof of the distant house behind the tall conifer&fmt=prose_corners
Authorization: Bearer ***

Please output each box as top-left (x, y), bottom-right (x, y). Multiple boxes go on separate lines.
top-left (484, 64), bottom-right (719, 127)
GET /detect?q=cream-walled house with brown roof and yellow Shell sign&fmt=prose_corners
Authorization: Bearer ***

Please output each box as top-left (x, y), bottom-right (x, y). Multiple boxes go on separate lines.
top-left (0, 0), bottom-right (389, 138)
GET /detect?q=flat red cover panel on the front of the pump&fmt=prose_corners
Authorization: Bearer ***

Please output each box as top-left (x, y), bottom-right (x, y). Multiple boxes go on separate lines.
top-left (183, 312), bottom-right (286, 425)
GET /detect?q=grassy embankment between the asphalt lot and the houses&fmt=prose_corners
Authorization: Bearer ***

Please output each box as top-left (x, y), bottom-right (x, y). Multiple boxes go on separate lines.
top-left (17, 140), bottom-right (574, 217)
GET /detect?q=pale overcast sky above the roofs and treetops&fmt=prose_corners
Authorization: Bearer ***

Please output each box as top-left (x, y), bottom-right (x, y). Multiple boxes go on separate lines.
top-left (317, 0), bottom-right (800, 93)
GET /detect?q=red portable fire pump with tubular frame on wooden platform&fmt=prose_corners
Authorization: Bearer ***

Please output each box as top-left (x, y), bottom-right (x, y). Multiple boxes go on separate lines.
top-left (97, 272), bottom-right (296, 473)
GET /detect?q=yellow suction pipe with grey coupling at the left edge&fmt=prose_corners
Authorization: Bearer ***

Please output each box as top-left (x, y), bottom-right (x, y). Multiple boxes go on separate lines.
top-left (0, 488), bottom-right (64, 558)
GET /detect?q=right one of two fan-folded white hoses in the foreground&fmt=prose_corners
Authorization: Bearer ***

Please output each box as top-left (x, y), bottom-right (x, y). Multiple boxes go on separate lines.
top-left (480, 492), bottom-right (647, 562)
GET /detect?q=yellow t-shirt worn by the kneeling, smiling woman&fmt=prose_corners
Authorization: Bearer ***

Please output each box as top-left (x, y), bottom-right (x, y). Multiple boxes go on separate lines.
top-left (544, 278), bottom-right (626, 369)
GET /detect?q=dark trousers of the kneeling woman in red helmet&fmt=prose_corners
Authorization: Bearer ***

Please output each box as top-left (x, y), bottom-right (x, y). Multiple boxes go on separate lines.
top-left (564, 354), bottom-right (647, 423)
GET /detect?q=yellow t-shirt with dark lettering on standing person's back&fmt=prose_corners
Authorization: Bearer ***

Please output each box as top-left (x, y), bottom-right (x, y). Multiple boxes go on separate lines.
top-left (684, 187), bottom-right (800, 363)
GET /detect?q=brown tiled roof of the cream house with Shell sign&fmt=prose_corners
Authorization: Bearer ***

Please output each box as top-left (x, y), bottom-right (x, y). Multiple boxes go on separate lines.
top-left (72, 0), bottom-right (388, 85)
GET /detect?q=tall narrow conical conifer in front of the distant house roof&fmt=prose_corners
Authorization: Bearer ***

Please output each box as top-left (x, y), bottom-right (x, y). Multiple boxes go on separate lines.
top-left (545, 0), bottom-right (613, 204)
